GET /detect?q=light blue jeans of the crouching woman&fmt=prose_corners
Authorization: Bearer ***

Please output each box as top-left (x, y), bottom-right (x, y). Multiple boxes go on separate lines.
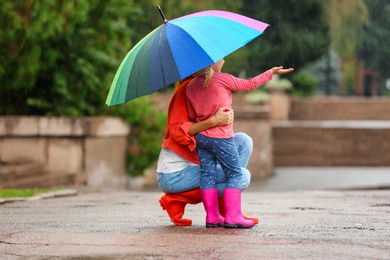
top-left (157, 133), bottom-right (253, 196)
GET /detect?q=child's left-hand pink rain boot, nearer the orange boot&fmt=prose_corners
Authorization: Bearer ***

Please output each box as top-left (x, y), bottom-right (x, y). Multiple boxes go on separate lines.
top-left (200, 188), bottom-right (224, 228)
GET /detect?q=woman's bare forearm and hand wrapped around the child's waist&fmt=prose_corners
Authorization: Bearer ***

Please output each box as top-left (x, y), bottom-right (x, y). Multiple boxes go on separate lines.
top-left (188, 107), bottom-right (234, 135)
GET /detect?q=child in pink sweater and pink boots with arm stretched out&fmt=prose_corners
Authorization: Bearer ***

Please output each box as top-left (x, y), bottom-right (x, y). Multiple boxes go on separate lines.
top-left (186, 59), bottom-right (293, 228)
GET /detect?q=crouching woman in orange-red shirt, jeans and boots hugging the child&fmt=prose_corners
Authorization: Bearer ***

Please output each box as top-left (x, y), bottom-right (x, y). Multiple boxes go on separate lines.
top-left (157, 78), bottom-right (259, 226)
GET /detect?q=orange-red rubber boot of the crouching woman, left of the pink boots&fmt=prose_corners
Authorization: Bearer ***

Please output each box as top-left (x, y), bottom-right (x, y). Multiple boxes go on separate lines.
top-left (159, 188), bottom-right (202, 226)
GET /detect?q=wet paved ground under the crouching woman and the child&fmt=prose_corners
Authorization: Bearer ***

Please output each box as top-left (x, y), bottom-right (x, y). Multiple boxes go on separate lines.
top-left (0, 168), bottom-right (390, 259)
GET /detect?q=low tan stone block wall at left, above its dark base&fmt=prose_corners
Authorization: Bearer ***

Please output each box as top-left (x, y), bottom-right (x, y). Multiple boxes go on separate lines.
top-left (0, 116), bottom-right (130, 189)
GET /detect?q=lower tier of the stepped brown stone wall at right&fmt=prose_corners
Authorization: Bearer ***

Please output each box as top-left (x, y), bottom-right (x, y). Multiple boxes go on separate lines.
top-left (273, 121), bottom-right (390, 166)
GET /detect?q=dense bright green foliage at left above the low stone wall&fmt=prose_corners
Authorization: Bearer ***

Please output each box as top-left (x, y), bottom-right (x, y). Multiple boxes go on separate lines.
top-left (0, 0), bottom-right (142, 116)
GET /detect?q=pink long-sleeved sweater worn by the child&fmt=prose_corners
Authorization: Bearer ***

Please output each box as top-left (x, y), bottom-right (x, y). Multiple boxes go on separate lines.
top-left (187, 70), bottom-right (272, 138)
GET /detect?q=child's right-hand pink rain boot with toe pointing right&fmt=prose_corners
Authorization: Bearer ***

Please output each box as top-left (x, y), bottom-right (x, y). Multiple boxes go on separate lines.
top-left (223, 188), bottom-right (254, 228)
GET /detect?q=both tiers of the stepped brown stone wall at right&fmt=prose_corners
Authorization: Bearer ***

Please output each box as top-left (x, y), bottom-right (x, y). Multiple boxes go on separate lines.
top-left (272, 97), bottom-right (390, 166)
